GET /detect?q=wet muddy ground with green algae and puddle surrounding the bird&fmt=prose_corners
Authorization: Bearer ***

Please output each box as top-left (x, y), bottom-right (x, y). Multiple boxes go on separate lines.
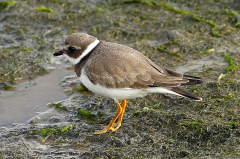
top-left (0, 0), bottom-right (240, 158)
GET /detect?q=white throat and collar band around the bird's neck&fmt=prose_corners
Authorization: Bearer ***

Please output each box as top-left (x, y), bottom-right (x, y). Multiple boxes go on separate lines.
top-left (63, 39), bottom-right (99, 65)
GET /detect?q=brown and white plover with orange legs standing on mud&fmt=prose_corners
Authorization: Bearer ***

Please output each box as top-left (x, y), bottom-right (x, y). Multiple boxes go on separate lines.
top-left (53, 32), bottom-right (204, 134)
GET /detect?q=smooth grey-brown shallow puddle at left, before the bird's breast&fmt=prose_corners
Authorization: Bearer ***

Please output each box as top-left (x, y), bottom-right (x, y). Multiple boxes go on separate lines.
top-left (0, 69), bottom-right (74, 126)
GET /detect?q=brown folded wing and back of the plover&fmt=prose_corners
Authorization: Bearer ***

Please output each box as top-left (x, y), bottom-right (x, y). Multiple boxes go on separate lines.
top-left (86, 42), bottom-right (189, 89)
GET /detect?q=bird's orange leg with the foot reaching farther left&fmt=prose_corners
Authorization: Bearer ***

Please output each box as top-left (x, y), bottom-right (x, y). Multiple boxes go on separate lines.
top-left (94, 101), bottom-right (123, 134)
